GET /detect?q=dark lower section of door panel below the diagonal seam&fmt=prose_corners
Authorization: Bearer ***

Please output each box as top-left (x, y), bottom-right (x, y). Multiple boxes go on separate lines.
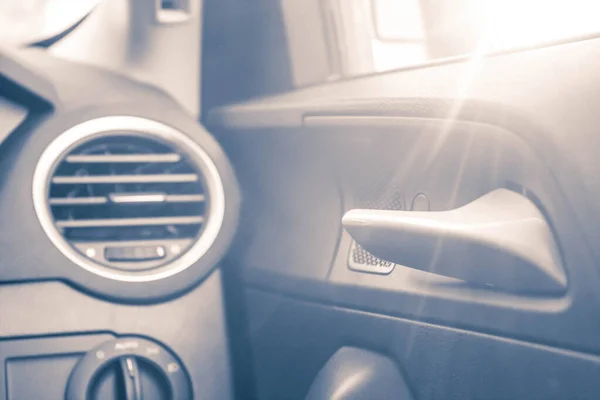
top-left (246, 290), bottom-right (600, 400)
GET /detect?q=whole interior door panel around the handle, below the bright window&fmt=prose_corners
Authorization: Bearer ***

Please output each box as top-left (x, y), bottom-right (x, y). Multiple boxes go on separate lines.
top-left (207, 39), bottom-right (600, 399)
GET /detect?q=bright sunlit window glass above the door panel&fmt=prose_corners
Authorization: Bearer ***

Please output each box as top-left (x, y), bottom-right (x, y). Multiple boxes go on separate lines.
top-left (332, 0), bottom-right (600, 76)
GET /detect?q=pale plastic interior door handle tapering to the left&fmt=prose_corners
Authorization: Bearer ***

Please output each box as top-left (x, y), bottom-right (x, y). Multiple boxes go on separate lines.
top-left (342, 189), bottom-right (567, 293)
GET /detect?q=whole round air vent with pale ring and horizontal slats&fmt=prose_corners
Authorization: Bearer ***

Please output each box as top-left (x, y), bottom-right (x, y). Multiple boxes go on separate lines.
top-left (33, 117), bottom-right (224, 282)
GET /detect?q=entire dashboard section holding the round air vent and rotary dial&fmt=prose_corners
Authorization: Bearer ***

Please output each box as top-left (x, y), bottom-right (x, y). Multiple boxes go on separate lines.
top-left (0, 50), bottom-right (240, 399)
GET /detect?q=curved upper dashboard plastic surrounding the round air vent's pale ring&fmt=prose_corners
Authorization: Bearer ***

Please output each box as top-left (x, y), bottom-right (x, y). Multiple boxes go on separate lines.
top-left (0, 51), bottom-right (240, 301)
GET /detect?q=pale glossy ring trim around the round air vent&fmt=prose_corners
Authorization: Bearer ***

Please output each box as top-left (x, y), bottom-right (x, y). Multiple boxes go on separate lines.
top-left (32, 116), bottom-right (225, 282)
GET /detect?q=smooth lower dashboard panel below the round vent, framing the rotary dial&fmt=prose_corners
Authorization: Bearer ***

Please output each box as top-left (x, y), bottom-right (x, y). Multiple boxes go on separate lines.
top-left (0, 270), bottom-right (233, 400)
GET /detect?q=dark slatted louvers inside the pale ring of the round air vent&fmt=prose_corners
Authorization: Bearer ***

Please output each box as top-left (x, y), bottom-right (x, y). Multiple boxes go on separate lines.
top-left (49, 135), bottom-right (209, 267)
